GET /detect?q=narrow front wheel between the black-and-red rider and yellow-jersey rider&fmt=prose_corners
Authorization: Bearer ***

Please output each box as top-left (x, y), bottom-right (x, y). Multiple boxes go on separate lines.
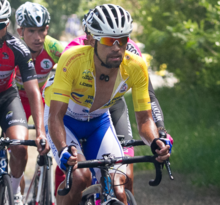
top-left (40, 158), bottom-right (52, 205)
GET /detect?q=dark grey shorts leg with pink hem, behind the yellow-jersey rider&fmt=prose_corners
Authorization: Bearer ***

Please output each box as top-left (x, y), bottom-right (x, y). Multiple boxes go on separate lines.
top-left (109, 97), bottom-right (134, 157)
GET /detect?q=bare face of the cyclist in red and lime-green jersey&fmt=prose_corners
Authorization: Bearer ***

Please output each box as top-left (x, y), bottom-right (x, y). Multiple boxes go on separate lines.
top-left (22, 26), bottom-right (49, 51)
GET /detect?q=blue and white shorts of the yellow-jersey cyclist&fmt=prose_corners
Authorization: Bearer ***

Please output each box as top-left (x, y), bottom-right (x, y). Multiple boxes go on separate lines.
top-left (44, 105), bottom-right (126, 181)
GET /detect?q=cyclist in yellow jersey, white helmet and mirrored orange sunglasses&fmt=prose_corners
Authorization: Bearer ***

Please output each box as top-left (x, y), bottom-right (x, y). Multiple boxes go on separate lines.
top-left (44, 4), bottom-right (170, 205)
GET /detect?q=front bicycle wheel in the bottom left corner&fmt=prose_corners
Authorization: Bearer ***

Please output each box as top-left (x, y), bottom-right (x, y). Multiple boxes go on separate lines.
top-left (0, 175), bottom-right (14, 205)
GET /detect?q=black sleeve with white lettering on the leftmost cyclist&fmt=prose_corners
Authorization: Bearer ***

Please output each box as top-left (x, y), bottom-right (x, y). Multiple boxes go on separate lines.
top-left (13, 39), bottom-right (37, 82)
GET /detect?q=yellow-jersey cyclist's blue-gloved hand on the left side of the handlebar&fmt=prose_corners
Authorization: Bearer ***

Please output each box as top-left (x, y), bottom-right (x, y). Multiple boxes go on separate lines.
top-left (59, 146), bottom-right (78, 171)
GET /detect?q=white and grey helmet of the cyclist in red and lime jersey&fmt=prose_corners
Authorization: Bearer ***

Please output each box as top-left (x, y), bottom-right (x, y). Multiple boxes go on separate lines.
top-left (15, 2), bottom-right (50, 27)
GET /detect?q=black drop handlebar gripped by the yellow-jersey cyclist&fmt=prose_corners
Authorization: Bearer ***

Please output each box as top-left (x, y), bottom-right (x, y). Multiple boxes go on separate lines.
top-left (58, 155), bottom-right (162, 196)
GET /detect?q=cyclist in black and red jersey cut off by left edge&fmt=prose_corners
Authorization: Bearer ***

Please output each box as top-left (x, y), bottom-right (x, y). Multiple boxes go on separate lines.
top-left (0, 0), bottom-right (49, 205)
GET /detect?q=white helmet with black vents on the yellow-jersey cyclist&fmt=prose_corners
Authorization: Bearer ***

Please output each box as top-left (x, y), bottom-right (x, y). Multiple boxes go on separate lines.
top-left (86, 4), bottom-right (132, 37)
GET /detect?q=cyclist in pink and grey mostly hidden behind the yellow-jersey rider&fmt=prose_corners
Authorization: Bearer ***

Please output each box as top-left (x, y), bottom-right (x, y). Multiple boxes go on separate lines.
top-left (55, 10), bottom-right (172, 194)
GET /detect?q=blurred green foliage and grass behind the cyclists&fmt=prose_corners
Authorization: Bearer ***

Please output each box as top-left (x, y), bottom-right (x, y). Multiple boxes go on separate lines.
top-left (6, 0), bottom-right (220, 202)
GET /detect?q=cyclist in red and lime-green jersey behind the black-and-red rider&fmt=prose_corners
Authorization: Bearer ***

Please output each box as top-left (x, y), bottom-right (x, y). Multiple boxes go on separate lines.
top-left (15, 2), bottom-right (64, 120)
